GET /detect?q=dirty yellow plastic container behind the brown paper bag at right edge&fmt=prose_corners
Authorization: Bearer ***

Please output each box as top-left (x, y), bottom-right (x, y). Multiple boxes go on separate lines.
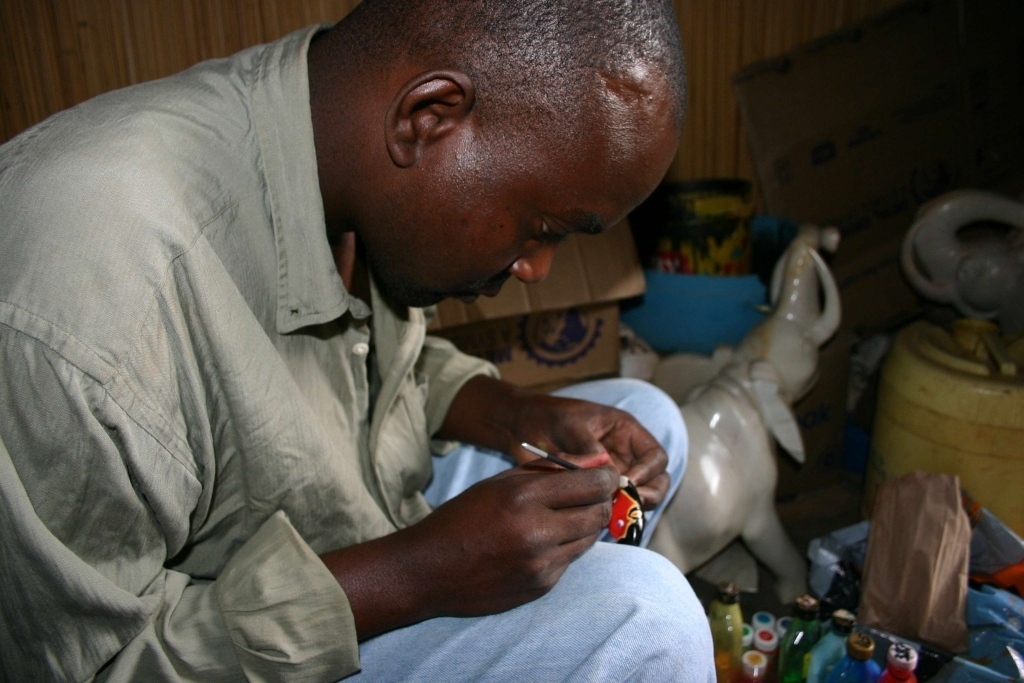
top-left (862, 318), bottom-right (1024, 536)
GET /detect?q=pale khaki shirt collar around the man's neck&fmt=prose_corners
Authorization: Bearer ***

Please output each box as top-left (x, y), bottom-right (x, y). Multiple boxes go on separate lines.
top-left (252, 25), bottom-right (370, 334)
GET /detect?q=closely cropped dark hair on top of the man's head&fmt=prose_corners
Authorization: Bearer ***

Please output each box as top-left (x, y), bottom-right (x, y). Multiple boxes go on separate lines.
top-left (327, 0), bottom-right (686, 132)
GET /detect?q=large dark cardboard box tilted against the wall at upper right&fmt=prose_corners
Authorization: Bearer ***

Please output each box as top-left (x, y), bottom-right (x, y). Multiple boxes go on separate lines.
top-left (733, 0), bottom-right (1024, 335)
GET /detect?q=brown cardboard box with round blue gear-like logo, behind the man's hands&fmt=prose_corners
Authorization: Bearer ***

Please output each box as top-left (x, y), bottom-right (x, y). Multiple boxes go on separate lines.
top-left (430, 221), bottom-right (645, 387)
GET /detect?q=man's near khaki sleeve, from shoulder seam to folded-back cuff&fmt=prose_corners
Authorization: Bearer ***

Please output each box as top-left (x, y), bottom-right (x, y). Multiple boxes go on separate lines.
top-left (0, 325), bottom-right (359, 681)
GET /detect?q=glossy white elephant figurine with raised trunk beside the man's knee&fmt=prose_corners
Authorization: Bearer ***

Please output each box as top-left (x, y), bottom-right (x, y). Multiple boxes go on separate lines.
top-left (650, 225), bottom-right (841, 603)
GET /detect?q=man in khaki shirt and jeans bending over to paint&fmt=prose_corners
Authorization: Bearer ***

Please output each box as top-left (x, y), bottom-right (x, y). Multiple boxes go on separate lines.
top-left (0, 0), bottom-right (712, 681)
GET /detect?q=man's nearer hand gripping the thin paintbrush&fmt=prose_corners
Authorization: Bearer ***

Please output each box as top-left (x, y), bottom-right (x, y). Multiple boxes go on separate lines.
top-left (399, 459), bottom-right (618, 618)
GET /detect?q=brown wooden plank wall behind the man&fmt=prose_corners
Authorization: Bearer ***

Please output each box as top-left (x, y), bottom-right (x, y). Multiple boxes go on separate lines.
top-left (0, 0), bottom-right (898, 184)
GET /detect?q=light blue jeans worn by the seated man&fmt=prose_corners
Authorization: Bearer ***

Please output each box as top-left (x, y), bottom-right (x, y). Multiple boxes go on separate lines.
top-left (345, 379), bottom-right (715, 683)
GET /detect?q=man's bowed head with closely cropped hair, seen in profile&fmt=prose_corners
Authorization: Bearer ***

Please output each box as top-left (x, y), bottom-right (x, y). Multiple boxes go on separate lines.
top-left (310, 0), bottom-right (685, 305)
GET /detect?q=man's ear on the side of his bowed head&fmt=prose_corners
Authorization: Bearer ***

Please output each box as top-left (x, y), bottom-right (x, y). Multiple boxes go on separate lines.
top-left (384, 69), bottom-right (476, 168)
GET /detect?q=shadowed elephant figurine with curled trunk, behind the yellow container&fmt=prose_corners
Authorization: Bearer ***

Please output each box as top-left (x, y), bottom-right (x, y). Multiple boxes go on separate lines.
top-left (900, 189), bottom-right (1024, 335)
